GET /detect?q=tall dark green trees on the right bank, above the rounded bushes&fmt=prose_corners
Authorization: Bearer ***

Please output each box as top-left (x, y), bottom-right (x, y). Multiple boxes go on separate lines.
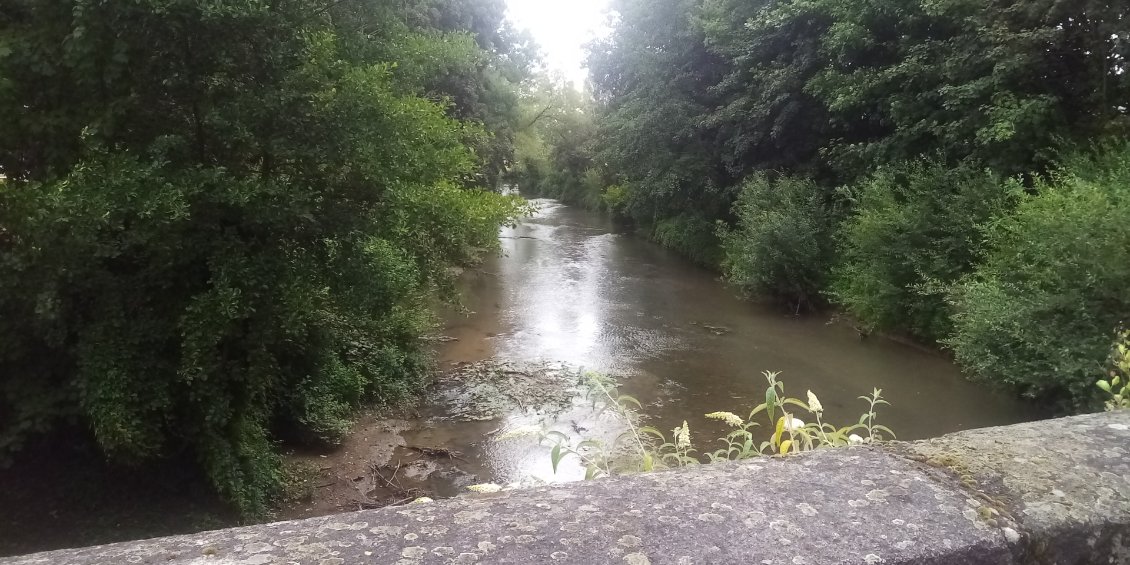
top-left (589, 0), bottom-right (1130, 272)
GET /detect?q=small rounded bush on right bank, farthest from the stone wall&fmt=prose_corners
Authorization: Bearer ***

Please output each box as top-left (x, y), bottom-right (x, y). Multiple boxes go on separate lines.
top-left (719, 174), bottom-right (835, 310)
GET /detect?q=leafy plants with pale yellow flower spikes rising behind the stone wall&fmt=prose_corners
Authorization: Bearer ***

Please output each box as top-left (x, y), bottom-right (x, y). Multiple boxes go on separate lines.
top-left (526, 372), bottom-right (895, 479)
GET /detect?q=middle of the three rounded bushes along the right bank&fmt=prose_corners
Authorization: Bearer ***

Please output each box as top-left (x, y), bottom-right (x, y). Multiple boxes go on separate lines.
top-left (831, 162), bottom-right (1020, 340)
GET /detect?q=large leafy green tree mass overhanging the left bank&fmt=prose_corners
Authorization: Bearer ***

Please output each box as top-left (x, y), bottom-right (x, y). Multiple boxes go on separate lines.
top-left (0, 0), bottom-right (525, 515)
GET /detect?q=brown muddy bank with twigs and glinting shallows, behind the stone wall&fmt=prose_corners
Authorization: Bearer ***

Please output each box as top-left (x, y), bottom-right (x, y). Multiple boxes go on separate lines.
top-left (280, 359), bottom-right (624, 519)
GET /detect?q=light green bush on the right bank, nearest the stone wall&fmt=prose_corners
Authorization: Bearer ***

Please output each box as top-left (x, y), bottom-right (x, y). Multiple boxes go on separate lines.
top-left (947, 144), bottom-right (1130, 408)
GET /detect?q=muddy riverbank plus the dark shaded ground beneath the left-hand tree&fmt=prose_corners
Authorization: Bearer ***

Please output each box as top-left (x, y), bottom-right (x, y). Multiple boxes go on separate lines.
top-left (0, 360), bottom-right (601, 556)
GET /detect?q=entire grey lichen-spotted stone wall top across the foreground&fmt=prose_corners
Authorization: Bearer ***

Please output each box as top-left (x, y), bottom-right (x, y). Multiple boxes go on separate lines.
top-left (0, 412), bottom-right (1130, 565)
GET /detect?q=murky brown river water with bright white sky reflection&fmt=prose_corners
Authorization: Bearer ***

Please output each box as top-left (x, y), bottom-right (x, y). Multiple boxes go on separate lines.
top-left (407, 200), bottom-right (1040, 494)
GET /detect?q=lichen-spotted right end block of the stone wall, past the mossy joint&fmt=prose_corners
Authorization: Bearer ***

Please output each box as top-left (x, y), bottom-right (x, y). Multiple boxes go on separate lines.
top-left (894, 411), bottom-right (1130, 564)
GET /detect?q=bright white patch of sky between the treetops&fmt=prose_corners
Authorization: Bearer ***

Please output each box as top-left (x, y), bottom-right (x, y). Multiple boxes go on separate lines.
top-left (506, 0), bottom-right (608, 88)
